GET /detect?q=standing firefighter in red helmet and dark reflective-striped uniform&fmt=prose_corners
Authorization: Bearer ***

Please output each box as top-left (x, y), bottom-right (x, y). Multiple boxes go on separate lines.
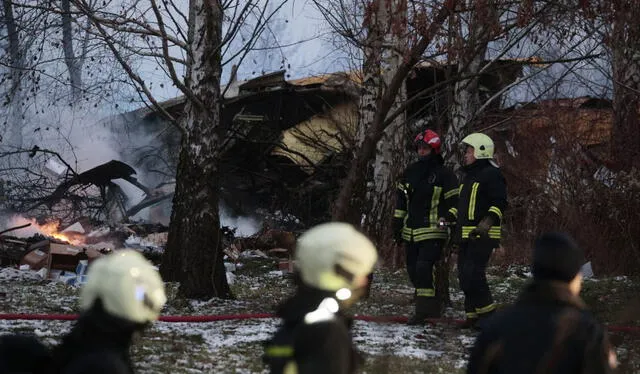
top-left (394, 130), bottom-right (458, 325)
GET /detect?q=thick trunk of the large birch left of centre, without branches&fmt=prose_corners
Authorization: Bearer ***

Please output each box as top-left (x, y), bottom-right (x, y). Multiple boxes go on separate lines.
top-left (160, 0), bottom-right (231, 299)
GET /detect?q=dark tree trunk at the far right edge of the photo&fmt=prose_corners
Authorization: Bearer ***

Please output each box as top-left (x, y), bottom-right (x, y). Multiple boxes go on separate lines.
top-left (611, 0), bottom-right (640, 170)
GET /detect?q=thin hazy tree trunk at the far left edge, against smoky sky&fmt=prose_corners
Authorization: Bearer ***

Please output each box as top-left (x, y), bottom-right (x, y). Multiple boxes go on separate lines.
top-left (2, 0), bottom-right (25, 148)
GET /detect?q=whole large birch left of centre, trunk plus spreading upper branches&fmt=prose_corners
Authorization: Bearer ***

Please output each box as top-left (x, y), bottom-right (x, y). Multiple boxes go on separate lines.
top-left (66, 0), bottom-right (284, 298)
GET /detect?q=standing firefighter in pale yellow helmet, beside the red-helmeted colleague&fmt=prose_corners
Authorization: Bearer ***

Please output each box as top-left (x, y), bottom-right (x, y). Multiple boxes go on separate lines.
top-left (447, 133), bottom-right (507, 328)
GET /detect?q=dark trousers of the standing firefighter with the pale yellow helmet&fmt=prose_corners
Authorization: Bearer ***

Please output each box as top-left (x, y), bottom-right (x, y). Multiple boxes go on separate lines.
top-left (458, 239), bottom-right (495, 318)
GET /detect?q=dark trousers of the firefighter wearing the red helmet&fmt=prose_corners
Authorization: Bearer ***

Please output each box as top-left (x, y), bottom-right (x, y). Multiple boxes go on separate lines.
top-left (405, 239), bottom-right (444, 297)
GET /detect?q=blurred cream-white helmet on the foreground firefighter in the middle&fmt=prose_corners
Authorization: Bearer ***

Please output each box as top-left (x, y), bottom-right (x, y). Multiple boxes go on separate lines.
top-left (295, 222), bottom-right (378, 291)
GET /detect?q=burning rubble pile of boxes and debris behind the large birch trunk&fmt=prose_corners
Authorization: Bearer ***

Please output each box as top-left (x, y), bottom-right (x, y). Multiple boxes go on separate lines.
top-left (0, 219), bottom-right (297, 285)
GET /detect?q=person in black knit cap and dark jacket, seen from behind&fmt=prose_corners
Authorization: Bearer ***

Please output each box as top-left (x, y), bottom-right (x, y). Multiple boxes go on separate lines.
top-left (467, 233), bottom-right (617, 374)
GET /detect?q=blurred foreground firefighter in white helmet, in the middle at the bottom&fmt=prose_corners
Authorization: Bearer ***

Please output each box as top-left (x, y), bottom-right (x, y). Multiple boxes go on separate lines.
top-left (263, 222), bottom-right (378, 374)
